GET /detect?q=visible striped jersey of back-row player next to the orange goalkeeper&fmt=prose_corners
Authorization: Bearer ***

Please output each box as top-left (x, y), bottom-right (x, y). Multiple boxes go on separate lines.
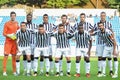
top-left (26, 23), bottom-right (38, 44)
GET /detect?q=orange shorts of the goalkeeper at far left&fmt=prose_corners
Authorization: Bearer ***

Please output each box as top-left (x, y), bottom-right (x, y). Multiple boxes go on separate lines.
top-left (4, 41), bottom-right (17, 55)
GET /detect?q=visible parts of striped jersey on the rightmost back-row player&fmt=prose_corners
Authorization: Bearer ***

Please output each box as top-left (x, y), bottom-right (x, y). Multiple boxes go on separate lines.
top-left (94, 21), bottom-right (112, 45)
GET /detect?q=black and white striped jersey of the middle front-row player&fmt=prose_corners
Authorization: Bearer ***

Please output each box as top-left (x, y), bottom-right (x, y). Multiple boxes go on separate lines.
top-left (54, 31), bottom-right (73, 48)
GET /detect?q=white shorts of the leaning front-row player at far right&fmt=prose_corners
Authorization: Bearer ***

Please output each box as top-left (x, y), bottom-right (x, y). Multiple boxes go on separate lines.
top-left (102, 46), bottom-right (118, 58)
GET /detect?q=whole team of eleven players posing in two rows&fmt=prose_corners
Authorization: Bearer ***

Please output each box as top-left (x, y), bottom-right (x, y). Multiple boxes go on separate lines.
top-left (3, 12), bottom-right (118, 78)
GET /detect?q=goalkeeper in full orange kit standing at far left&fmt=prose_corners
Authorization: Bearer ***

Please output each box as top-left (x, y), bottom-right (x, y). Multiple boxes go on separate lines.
top-left (3, 12), bottom-right (19, 76)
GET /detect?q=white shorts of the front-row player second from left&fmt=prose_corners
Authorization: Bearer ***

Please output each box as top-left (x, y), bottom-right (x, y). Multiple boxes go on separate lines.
top-left (34, 47), bottom-right (49, 57)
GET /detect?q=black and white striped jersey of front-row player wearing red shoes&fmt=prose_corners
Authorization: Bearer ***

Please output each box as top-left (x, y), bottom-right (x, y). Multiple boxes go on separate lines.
top-left (74, 31), bottom-right (92, 48)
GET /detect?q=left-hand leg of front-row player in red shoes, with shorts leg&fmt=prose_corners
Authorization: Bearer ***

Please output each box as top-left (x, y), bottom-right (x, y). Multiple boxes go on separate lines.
top-left (74, 49), bottom-right (81, 77)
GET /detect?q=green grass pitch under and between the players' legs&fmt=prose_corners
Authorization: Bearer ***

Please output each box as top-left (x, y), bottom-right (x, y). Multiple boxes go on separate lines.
top-left (0, 57), bottom-right (120, 80)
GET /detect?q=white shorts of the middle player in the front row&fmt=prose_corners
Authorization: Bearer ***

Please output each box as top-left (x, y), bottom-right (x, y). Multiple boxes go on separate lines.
top-left (55, 48), bottom-right (71, 58)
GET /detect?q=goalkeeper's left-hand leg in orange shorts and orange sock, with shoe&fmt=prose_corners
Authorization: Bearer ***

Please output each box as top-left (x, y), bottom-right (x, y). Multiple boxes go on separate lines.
top-left (3, 42), bottom-right (12, 76)
